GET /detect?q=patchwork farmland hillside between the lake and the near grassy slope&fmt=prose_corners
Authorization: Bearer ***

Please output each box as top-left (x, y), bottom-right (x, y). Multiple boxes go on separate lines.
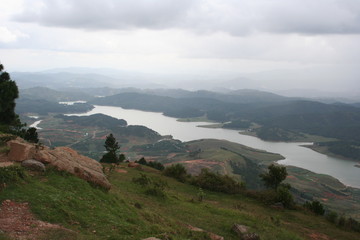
top-left (23, 114), bottom-right (360, 219)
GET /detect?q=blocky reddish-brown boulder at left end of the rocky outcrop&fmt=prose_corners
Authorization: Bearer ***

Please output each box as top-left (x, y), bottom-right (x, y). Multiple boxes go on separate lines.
top-left (8, 138), bottom-right (35, 162)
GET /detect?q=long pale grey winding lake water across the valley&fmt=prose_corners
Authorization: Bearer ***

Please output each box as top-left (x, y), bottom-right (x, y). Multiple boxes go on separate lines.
top-left (69, 106), bottom-right (360, 188)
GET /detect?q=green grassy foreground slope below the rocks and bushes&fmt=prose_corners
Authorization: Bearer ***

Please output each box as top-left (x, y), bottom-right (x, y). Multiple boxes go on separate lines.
top-left (0, 168), bottom-right (359, 240)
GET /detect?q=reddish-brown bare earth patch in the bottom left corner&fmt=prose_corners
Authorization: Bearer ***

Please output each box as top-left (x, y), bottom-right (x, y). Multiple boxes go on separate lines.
top-left (0, 200), bottom-right (74, 240)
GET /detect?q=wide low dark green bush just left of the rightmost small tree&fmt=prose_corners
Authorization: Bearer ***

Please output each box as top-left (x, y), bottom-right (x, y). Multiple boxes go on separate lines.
top-left (192, 168), bottom-right (245, 194)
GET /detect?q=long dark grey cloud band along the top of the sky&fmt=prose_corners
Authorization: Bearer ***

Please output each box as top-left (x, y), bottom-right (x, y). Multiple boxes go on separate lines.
top-left (15, 0), bottom-right (360, 35)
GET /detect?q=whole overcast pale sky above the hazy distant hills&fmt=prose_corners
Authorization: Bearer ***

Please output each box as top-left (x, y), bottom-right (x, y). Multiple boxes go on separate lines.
top-left (0, 0), bottom-right (360, 93)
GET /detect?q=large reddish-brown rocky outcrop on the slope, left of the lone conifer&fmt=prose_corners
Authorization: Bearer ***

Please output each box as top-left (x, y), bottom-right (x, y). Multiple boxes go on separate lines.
top-left (8, 138), bottom-right (111, 189)
